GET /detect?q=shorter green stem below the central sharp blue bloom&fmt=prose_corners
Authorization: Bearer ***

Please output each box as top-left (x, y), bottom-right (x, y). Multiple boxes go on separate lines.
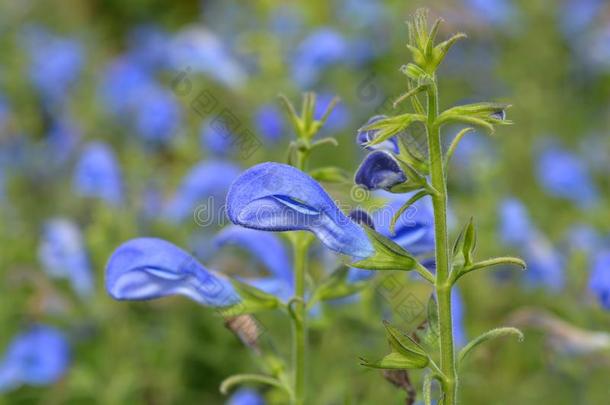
top-left (292, 235), bottom-right (309, 405)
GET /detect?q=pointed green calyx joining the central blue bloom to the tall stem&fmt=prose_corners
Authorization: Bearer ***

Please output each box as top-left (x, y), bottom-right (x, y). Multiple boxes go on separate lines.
top-left (349, 226), bottom-right (416, 271)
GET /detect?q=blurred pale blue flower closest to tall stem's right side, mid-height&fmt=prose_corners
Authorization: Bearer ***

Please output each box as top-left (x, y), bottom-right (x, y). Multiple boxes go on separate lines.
top-left (500, 198), bottom-right (537, 246)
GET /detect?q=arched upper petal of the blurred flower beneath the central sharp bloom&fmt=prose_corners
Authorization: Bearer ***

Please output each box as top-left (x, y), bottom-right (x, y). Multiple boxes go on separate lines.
top-left (214, 226), bottom-right (293, 285)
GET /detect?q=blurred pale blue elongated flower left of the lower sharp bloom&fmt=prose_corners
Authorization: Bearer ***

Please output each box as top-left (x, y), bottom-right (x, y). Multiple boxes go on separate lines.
top-left (38, 218), bottom-right (94, 297)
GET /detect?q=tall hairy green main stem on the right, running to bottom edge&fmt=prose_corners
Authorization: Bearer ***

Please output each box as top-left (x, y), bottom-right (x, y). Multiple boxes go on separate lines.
top-left (427, 79), bottom-right (458, 405)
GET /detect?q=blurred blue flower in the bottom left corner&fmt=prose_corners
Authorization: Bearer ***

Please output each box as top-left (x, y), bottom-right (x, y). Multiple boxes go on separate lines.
top-left (0, 325), bottom-right (70, 392)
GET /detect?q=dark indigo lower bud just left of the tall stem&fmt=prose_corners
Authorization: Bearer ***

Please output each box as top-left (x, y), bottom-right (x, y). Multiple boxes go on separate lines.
top-left (354, 150), bottom-right (407, 190)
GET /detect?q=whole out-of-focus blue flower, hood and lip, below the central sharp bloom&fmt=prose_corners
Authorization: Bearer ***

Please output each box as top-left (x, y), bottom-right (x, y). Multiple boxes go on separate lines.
top-left (214, 225), bottom-right (294, 301)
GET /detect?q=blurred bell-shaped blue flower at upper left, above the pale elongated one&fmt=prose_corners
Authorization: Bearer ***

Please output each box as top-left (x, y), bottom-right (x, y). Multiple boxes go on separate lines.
top-left (73, 142), bottom-right (123, 205)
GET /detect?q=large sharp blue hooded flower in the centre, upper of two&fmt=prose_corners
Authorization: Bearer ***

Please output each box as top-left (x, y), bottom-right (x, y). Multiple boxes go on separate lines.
top-left (227, 162), bottom-right (373, 258)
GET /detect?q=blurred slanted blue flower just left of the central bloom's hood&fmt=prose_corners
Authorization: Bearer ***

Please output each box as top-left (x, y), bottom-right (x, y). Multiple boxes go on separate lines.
top-left (165, 160), bottom-right (241, 222)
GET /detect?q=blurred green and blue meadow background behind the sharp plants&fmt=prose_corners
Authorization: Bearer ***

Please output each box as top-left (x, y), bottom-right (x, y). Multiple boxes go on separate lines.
top-left (0, 0), bottom-right (610, 404)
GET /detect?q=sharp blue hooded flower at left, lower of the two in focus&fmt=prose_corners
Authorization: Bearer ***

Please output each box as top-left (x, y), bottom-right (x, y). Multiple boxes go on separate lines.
top-left (106, 238), bottom-right (240, 307)
